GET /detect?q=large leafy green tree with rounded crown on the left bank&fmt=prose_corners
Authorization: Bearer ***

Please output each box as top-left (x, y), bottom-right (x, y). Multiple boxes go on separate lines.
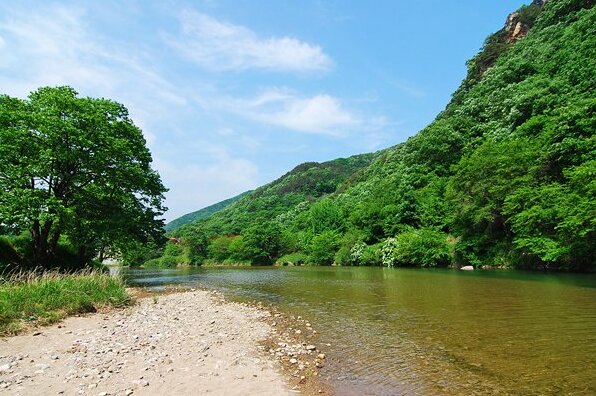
top-left (0, 87), bottom-right (166, 267)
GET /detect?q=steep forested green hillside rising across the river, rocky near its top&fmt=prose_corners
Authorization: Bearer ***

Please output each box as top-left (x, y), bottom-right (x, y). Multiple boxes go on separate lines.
top-left (158, 0), bottom-right (596, 270)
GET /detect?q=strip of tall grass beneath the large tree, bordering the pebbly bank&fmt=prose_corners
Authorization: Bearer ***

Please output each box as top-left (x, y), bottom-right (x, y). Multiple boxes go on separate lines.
top-left (0, 272), bottom-right (130, 335)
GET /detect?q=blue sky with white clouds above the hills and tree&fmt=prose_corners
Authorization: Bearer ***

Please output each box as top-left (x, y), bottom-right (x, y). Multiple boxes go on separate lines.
top-left (0, 0), bottom-right (523, 220)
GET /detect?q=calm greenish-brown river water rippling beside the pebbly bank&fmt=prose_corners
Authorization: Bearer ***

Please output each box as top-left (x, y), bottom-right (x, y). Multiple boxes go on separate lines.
top-left (124, 267), bottom-right (596, 395)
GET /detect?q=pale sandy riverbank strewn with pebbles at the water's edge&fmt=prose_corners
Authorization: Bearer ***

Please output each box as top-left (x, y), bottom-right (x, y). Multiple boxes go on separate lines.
top-left (0, 291), bottom-right (326, 396)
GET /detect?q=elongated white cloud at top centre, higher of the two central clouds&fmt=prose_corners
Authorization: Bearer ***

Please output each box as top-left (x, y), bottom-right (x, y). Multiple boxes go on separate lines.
top-left (165, 11), bottom-right (332, 72)
